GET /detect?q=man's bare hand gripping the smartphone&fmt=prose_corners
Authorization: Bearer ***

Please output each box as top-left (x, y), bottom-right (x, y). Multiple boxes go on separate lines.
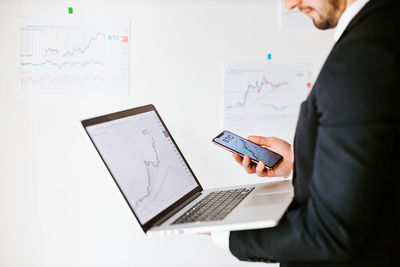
top-left (232, 136), bottom-right (293, 177)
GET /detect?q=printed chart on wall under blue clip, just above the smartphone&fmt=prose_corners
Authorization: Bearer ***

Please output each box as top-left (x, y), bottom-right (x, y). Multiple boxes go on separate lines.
top-left (223, 63), bottom-right (311, 136)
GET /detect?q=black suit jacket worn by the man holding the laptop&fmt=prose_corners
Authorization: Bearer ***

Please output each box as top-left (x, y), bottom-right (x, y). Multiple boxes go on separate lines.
top-left (229, 0), bottom-right (400, 266)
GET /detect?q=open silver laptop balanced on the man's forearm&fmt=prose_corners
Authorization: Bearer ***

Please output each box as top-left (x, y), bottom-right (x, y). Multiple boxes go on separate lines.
top-left (82, 105), bottom-right (293, 235)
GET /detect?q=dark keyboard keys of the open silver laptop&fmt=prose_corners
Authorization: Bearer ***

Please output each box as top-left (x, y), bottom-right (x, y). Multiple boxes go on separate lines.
top-left (172, 187), bottom-right (254, 224)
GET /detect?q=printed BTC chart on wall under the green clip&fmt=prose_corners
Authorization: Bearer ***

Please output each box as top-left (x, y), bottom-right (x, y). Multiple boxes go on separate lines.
top-left (20, 18), bottom-right (130, 95)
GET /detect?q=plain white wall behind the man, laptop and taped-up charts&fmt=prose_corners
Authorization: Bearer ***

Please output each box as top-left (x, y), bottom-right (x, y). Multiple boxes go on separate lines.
top-left (0, 0), bottom-right (333, 266)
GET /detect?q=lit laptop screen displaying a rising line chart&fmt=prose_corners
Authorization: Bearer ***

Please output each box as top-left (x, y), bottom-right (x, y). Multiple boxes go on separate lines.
top-left (82, 105), bottom-right (199, 225)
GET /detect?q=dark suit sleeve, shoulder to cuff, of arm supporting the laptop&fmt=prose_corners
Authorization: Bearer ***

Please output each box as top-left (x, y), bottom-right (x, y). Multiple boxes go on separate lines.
top-left (230, 13), bottom-right (399, 262)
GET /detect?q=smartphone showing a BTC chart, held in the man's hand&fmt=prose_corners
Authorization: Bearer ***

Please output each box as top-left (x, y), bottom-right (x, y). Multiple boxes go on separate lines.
top-left (212, 131), bottom-right (283, 169)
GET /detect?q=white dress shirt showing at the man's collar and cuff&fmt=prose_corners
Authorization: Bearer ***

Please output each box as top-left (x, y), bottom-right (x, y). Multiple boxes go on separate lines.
top-left (211, 0), bottom-right (369, 251)
